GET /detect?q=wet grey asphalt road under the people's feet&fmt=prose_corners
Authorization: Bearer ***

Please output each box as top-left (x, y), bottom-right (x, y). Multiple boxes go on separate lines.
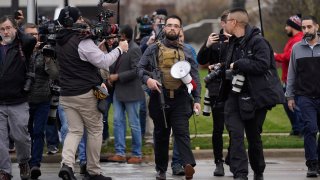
top-left (12, 157), bottom-right (310, 180)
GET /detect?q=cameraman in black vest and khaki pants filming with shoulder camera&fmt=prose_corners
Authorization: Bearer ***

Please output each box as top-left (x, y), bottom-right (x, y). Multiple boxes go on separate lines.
top-left (56, 6), bottom-right (128, 180)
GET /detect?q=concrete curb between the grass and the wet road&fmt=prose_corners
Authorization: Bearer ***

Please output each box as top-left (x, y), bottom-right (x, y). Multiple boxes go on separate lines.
top-left (10, 149), bottom-right (304, 163)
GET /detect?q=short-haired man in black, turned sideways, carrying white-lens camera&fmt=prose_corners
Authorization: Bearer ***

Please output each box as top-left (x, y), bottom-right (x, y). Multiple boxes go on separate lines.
top-left (225, 8), bottom-right (285, 180)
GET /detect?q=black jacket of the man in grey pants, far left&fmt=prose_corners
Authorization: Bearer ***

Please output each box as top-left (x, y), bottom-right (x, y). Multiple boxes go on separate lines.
top-left (0, 30), bottom-right (36, 105)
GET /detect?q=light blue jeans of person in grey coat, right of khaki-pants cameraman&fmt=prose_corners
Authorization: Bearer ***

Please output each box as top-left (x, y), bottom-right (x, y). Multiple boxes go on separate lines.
top-left (113, 94), bottom-right (142, 157)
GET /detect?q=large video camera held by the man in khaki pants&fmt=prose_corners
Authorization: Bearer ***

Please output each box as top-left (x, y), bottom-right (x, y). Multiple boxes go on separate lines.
top-left (93, 0), bottom-right (119, 41)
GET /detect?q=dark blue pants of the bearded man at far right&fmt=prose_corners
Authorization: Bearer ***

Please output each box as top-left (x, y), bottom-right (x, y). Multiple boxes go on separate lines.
top-left (296, 96), bottom-right (320, 162)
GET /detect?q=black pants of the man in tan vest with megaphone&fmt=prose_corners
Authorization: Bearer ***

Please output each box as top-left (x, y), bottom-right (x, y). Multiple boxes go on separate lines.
top-left (149, 90), bottom-right (196, 172)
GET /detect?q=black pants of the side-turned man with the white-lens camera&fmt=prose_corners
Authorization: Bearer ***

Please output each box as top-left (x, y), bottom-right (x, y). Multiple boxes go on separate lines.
top-left (225, 94), bottom-right (267, 177)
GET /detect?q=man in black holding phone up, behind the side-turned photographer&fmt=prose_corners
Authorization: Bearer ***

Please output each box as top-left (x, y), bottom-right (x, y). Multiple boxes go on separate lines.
top-left (197, 11), bottom-right (230, 176)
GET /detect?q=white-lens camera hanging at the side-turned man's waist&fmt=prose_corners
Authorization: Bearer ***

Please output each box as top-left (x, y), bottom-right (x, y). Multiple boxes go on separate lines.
top-left (226, 69), bottom-right (246, 93)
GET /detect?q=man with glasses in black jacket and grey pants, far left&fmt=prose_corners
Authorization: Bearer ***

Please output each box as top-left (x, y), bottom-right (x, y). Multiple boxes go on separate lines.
top-left (0, 16), bottom-right (36, 179)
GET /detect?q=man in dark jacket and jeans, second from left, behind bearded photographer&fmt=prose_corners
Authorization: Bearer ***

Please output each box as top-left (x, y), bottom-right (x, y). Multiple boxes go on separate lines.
top-left (24, 23), bottom-right (58, 179)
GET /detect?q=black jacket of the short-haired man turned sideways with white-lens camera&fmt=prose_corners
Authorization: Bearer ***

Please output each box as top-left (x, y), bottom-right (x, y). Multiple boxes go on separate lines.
top-left (227, 26), bottom-right (285, 108)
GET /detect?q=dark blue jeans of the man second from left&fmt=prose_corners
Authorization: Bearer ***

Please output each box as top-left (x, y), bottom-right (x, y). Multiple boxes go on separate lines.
top-left (28, 101), bottom-right (50, 167)
